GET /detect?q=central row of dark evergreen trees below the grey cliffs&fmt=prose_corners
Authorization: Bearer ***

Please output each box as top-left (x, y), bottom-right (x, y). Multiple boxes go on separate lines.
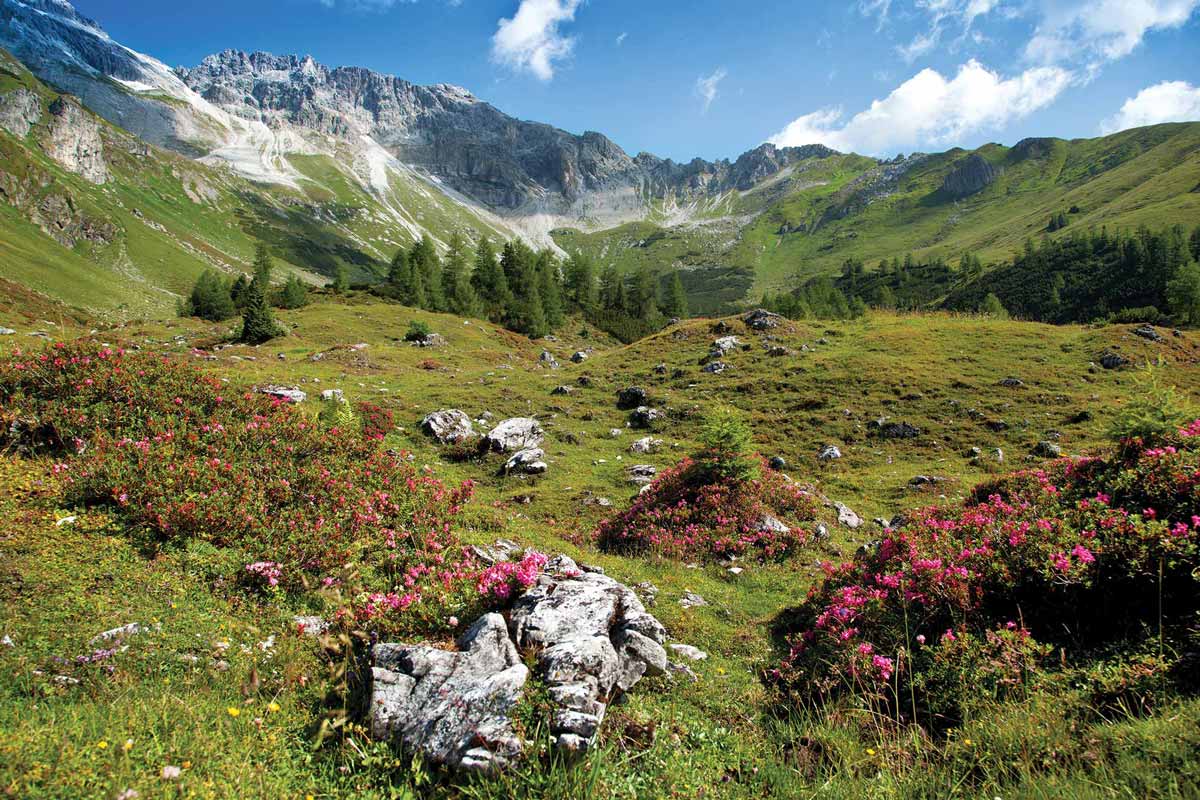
top-left (374, 234), bottom-right (688, 342)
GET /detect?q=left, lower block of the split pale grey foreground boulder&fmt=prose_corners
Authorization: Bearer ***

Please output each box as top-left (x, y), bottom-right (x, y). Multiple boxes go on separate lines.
top-left (370, 614), bottom-right (529, 772)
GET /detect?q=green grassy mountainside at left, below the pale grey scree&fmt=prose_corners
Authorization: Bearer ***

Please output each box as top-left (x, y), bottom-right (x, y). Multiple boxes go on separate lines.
top-left (0, 52), bottom-right (511, 319)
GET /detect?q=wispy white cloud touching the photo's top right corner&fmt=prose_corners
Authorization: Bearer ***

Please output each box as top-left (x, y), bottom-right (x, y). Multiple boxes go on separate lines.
top-left (1025, 0), bottom-right (1200, 68)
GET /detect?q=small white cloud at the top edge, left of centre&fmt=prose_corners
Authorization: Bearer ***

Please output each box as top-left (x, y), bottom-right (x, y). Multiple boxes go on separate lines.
top-left (492, 0), bottom-right (583, 80)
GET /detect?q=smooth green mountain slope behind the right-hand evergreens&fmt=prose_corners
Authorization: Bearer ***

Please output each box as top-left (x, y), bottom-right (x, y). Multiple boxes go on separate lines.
top-left (556, 122), bottom-right (1200, 298)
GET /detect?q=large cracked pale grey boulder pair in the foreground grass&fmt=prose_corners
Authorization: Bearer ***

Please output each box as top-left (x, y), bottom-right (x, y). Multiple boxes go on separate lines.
top-left (367, 553), bottom-right (681, 772)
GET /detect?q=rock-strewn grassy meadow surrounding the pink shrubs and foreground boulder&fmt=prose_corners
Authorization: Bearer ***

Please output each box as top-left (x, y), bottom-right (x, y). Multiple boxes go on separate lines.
top-left (0, 296), bottom-right (1200, 798)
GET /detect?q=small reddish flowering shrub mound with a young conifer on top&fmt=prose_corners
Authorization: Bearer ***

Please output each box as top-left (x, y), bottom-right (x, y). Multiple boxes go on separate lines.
top-left (596, 458), bottom-right (817, 559)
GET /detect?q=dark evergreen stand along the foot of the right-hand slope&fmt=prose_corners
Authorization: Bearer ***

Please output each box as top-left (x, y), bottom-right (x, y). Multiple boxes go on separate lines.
top-left (763, 221), bottom-right (1200, 325)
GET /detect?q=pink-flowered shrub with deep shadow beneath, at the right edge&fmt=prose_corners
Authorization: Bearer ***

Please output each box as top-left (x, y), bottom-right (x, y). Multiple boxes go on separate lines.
top-left (774, 427), bottom-right (1200, 722)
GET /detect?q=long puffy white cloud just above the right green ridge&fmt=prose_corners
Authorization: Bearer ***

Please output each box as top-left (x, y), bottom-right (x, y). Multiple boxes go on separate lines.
top-left (769, 59), bottom-right (1074, 155)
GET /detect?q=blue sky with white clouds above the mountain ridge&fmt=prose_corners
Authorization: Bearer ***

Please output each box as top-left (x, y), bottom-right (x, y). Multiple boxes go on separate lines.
top-left (76, 0), bottom-right (1200, 160)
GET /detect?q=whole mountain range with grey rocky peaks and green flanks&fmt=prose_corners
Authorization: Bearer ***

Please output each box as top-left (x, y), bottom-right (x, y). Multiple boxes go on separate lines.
top-left (0, 0), bottom-right (1200, 315)
